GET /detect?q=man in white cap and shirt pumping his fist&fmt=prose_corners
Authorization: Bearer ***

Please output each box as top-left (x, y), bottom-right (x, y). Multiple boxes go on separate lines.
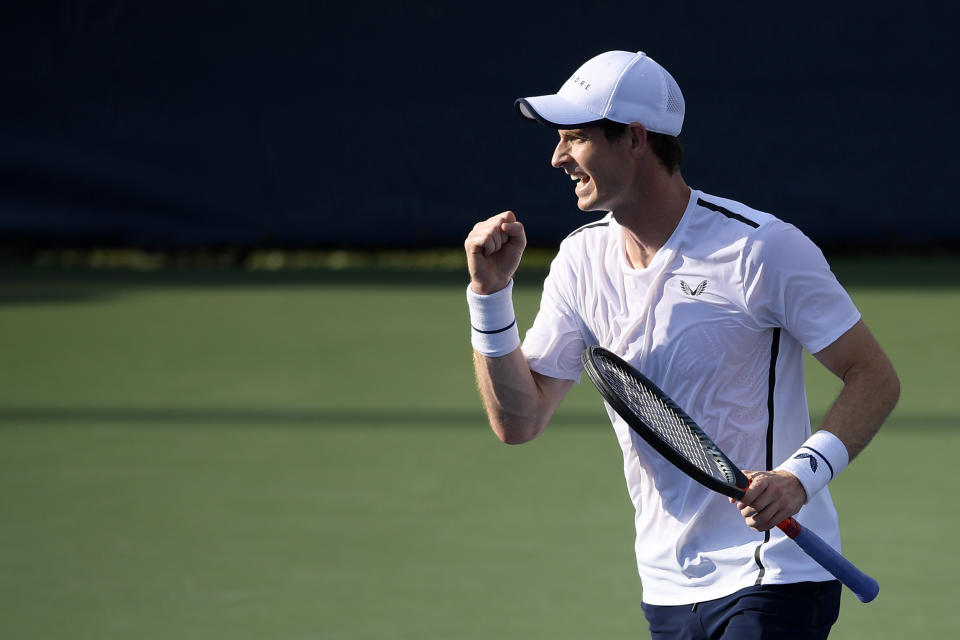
top-left (465, 51), bottom-right (899, 639)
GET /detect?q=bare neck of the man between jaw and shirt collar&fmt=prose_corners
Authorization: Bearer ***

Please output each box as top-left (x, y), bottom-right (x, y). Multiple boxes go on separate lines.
top-left (613, 171), bottom-right (690, 269)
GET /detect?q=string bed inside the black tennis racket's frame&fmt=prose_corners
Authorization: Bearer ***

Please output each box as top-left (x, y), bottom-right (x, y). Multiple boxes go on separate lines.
top-left (601, 361), bottom-right (731, 482)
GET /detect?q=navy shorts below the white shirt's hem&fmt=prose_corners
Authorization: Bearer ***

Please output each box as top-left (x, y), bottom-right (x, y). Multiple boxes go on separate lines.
top-left (642, 581), bottom-right (841, 640)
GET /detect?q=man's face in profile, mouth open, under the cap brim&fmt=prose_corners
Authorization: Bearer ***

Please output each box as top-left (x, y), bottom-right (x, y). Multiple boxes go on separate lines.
top-left (550, 127), bottom-right (634, 211)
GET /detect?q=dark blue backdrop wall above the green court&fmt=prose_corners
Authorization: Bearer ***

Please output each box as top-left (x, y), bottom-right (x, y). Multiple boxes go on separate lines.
top-left (0, 0), bottom-right (960, 248)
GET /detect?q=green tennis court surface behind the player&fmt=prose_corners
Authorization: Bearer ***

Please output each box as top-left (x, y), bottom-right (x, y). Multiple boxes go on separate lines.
top-left (0, 258), bottom-right (960, 640)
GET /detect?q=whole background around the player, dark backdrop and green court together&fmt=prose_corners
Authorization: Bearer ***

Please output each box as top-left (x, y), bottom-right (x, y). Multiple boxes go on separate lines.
top-left (0, 0), bottom-right (960, 640)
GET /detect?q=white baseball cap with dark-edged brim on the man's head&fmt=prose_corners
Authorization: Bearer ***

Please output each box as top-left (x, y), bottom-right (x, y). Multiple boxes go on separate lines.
top-left (514, 51), bottom-right (684, 136)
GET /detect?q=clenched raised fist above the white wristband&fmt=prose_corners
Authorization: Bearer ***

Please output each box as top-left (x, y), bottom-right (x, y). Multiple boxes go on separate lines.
top-left (463, 211), bottom-right (527, 295)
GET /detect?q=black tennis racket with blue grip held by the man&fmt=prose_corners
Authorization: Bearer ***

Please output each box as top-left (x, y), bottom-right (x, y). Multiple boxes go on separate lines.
top-left (583, 346), bottom-right (880, 602)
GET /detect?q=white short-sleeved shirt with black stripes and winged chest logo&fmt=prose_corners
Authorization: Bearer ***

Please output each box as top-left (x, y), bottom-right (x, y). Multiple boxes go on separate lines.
top-left (523, 190), bottom-right (860, 605)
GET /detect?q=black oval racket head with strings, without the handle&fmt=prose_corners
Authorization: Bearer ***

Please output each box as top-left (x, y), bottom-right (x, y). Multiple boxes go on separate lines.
top-left (582, 346), bottom-right (750, 499)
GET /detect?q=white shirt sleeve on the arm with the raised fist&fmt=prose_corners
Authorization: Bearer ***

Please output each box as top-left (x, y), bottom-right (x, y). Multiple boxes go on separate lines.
top-left (522, 248), bottom-right (586, 383)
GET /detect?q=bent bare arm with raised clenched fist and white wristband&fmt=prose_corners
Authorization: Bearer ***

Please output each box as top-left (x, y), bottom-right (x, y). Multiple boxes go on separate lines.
top-left (464, 211), bottom-right (573, 444)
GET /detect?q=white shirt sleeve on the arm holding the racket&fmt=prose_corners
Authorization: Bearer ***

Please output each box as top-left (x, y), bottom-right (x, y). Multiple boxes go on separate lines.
top-left (743, 221), bottom-right (860, 353)
